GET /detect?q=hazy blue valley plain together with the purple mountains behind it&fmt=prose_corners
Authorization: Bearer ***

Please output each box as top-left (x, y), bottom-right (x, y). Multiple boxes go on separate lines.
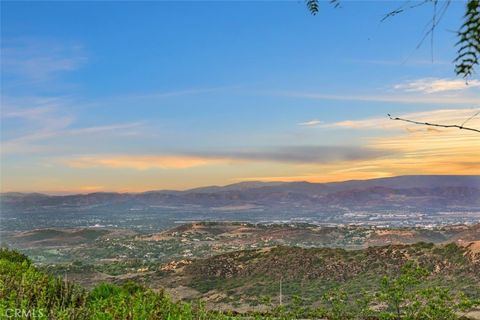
top-left (0, 175), bottom-right (480, 235)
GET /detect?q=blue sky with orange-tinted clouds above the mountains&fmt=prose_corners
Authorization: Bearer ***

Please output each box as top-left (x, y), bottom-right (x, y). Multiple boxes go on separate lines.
top-left (0, 1), bottom-right (480, 193)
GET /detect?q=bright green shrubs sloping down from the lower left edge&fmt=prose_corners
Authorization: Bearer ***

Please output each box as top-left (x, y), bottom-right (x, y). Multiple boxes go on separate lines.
top-left (0, 249), bottom-right (228, 320)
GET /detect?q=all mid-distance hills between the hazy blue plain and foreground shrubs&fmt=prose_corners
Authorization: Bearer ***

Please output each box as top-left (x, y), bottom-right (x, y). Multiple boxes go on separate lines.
top-left (3, 222), bottom-right (480, 312)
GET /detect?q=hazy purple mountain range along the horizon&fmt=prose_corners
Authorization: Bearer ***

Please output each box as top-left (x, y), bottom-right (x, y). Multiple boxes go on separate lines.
top-left (0, 175), bottom-right (480, 211)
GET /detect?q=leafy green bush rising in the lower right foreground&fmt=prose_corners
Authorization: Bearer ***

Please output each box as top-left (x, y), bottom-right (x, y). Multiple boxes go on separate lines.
top-left (322, 261), bottom-right (479, 320)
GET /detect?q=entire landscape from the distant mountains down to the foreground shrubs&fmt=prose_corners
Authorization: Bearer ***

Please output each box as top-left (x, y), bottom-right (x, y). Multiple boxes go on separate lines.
top-left (0, 176), bottom-right (480, 319)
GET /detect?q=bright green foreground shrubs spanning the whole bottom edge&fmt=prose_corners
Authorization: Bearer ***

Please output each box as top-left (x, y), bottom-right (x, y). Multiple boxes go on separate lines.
top-left (0, 249), bottom-right (479, 320)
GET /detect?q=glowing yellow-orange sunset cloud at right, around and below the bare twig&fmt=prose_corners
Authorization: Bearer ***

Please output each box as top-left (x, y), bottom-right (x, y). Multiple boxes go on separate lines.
top-left (298, 109), bottom-right (480, 181)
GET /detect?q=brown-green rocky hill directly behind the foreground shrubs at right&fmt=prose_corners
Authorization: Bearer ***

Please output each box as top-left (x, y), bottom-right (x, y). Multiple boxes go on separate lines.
top-left (156, 243), bottom-right (480, 308)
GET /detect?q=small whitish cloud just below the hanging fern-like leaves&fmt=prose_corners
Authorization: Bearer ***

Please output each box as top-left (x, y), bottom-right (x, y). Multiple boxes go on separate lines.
top-left (393, 78), bottom-right (480, 94)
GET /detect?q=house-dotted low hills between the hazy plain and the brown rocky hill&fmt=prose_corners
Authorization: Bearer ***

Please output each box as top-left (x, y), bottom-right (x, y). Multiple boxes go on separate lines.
top-left (6, 222), bottom-right (480, 272)
